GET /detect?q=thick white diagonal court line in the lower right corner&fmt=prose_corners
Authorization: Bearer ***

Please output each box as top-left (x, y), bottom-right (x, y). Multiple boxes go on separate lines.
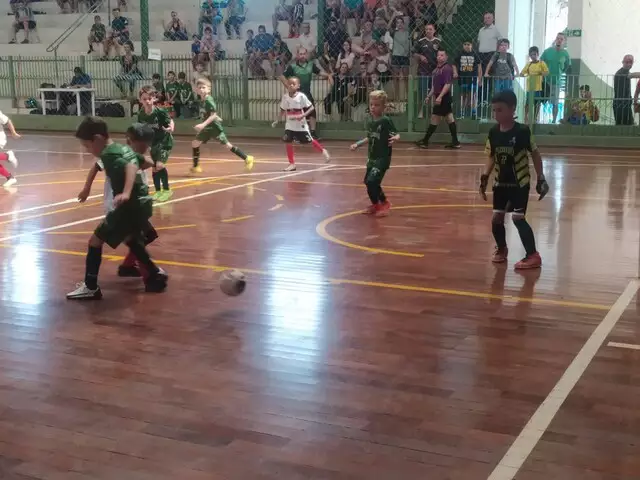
top-left (488, 280), bottom-right (640, 480)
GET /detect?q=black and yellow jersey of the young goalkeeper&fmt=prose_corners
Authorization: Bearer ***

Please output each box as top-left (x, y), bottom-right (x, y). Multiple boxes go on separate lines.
top-left (484, 122), bottom-right (538, 187)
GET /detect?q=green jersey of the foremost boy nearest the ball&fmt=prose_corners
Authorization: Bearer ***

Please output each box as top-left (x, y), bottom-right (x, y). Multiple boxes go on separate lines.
top-left (99, 143), bottom-right (149, 204)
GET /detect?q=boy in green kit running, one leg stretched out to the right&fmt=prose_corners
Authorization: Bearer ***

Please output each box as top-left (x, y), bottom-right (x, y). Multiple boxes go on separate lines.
top-left (191, 78), bottom-right (253, 173)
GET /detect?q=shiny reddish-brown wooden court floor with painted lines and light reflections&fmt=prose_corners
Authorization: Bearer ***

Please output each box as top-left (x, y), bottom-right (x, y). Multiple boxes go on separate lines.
top-left (0, 134), bottom-right (640, 480)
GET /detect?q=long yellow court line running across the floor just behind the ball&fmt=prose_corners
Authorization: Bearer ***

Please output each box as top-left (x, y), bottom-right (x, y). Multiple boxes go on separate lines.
top-left (0, 244), bottom-right (611, 311)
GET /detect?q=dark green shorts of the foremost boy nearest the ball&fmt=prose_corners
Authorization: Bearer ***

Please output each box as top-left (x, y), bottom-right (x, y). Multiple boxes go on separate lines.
top-left (93, 197), bottom-right (153, 249)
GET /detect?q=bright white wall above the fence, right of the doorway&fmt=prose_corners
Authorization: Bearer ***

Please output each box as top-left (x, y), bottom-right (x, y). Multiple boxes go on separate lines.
top-left (569, 0), bottom-right (640, 78)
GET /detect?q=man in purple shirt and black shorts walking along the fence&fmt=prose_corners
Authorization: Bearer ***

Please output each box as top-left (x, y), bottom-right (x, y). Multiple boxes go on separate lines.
top-left (416, 50), bottom-right (460, 148)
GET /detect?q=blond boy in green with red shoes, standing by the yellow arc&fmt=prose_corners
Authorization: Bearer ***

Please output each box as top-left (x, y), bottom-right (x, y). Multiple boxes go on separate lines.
top-left (351, 90), bottom-right (400, 217)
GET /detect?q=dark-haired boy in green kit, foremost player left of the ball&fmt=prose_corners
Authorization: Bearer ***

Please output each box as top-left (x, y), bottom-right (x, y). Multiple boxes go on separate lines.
top-left (67, 117), bottom-right (169, 300)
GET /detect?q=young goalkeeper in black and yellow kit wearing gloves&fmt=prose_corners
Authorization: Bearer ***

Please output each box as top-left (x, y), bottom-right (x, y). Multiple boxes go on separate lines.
top-left (480, 90), bottom-right (549, 270)
